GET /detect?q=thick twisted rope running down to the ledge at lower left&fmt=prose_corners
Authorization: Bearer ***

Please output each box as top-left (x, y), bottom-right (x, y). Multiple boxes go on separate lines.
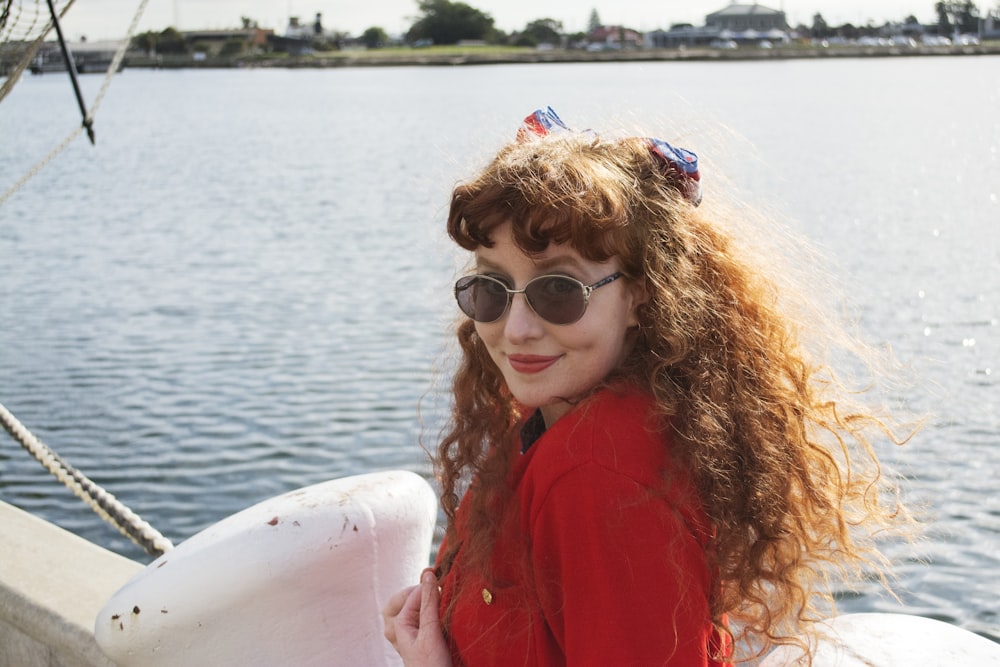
top-left (0, 404), bottom-right (174, 556)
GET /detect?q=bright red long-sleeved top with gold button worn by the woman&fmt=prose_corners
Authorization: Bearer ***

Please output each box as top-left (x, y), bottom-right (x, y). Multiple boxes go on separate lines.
top-left (442, 390), bottom-right (726, 667)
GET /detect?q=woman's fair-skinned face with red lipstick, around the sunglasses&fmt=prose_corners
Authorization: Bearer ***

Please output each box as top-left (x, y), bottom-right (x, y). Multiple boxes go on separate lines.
top-left (476, 223), bottom-right (640, 426)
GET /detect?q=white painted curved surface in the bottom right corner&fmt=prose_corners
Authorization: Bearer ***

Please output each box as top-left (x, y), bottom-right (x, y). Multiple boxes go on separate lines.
top-left (760, 614), bottom-right (1000, 667)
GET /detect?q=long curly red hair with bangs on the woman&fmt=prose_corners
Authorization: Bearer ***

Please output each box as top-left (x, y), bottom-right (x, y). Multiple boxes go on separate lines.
top-left (436, 133), bottom-right (908, 664)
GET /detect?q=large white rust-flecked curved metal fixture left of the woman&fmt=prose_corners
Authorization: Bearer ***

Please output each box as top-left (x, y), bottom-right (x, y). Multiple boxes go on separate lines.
top-left (95, 471), bottom-right (437, 667)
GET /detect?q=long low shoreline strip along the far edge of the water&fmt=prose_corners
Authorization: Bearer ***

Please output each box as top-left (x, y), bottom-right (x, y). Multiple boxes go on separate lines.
top-left (125, 42), bottom-right (1000, 69)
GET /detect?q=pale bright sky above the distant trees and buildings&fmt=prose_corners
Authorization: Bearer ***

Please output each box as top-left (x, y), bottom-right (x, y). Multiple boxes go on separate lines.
top-left (56, 0), bottom-right (960, 41)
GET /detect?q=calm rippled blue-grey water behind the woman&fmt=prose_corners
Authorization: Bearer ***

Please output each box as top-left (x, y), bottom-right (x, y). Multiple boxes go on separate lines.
top-left (0, 57), bottom-right (1000, 640)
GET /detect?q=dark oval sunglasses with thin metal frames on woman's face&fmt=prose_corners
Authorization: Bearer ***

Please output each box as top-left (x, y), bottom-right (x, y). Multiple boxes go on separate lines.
top-left (455, 271), bottom-right (622, 324)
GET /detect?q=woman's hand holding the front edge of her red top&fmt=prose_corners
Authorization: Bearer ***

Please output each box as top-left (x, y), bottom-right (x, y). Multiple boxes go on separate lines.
top-left (382, 569), bottom-right (451, 667)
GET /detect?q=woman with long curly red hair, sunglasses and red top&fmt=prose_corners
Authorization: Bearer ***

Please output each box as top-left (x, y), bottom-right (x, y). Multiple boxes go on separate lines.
top-left (384, 109), bottom-right (916, 667)
